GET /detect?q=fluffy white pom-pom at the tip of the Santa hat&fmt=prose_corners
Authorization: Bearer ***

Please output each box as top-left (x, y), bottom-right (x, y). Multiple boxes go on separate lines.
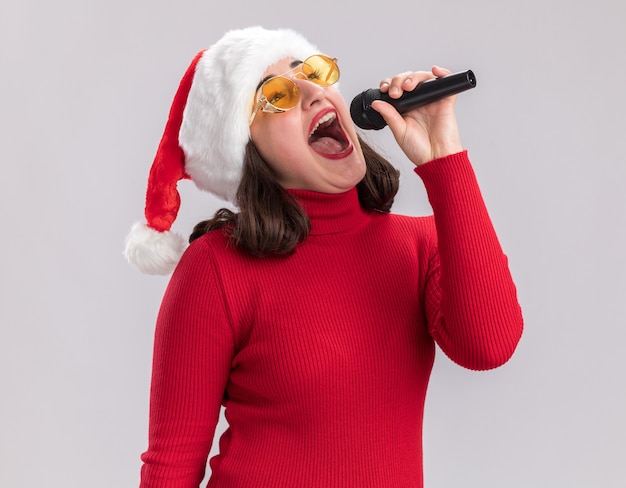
top-left (124, 222), bottom-right (187, 275)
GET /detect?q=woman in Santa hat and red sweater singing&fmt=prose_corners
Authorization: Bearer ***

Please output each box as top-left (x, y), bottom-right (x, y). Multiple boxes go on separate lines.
top-left (126, 27), bottom-right (522, 488)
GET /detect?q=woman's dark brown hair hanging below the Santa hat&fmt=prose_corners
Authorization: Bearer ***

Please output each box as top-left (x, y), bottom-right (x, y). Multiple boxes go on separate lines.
top-left (189, 138), bottom-right (399, 257)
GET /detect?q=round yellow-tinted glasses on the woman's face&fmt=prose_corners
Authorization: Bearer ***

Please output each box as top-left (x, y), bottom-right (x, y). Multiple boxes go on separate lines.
top-left (250, 54), bottom-right (339, 124)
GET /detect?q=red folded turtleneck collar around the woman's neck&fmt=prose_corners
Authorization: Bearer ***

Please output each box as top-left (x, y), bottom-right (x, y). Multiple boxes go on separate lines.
top-left (288, 188), bottom-right (368, 235)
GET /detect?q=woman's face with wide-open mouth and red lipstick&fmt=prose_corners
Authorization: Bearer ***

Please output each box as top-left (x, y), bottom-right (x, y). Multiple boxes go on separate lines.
top-left (250, 58), bottom-right (365, 193)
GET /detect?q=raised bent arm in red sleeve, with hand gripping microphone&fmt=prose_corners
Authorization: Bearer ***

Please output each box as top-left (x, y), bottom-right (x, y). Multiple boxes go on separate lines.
top-left (372, 67), bottom-right (523, 369)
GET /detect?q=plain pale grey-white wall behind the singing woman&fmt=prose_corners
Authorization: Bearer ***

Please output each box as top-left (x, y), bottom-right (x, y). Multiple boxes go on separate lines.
top-left (0, 0), bottom-right (626, 488)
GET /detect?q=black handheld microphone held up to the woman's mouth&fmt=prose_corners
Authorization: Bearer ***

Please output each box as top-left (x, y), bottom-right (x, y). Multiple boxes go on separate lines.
top-left (350, 70), bottom-right (476, 130)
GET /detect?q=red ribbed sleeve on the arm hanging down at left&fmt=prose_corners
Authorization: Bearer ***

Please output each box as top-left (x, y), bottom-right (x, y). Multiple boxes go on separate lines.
top-left (140, 239), bottom-right (233, 488)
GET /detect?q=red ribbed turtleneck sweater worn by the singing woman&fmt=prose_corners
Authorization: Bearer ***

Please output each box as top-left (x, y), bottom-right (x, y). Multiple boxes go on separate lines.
top-left (141, 152), bottom-right (522, 488)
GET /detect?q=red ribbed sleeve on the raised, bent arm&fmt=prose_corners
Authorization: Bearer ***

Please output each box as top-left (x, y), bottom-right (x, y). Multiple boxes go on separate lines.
top-left (415, 151), bottom-right (523, 370)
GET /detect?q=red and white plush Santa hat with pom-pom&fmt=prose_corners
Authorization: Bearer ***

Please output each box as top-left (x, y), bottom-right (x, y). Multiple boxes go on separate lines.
top-left (124, 27), bottom-right (319, 274)
